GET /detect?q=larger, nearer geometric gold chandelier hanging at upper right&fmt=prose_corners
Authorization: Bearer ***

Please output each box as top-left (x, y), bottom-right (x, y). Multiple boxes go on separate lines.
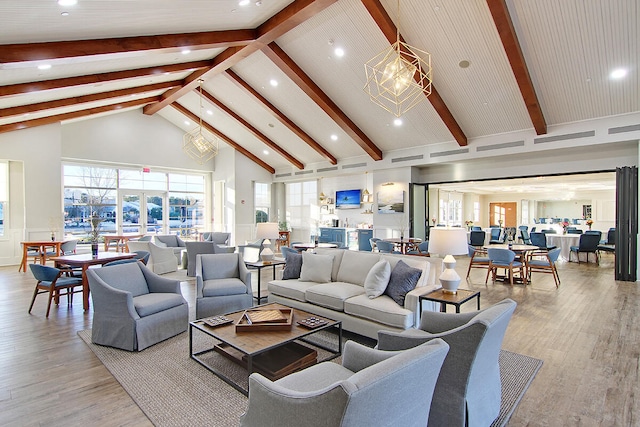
top-left (364, 0), bottom-right (432, 117)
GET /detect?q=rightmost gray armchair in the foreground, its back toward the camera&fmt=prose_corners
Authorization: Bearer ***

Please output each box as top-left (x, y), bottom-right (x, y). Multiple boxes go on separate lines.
top-left (378, 299), bottom-right (516, 426)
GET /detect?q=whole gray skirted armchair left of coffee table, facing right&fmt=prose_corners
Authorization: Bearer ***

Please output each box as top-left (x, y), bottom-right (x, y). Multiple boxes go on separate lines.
top-left (87, 262), bottom-right (189, 351)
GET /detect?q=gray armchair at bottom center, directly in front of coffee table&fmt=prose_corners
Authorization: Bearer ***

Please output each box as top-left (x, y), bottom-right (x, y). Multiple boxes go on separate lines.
top-left (240, 340), bottom-right (449, 427)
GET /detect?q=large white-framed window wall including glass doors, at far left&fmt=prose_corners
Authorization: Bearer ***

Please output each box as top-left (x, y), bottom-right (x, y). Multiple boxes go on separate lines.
top-left (63, 165), bottom-right (205, 237)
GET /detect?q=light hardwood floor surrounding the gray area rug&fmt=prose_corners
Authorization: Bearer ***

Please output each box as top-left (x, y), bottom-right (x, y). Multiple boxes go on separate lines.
top-left (0, 255), bottom-right (640, 426)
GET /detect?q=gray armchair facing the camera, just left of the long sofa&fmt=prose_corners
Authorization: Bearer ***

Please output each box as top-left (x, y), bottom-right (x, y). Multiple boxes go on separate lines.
top-left (196, 253), bottom-right (253, 319)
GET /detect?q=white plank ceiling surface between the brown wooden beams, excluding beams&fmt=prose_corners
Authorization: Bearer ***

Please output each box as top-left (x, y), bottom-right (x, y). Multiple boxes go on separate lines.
top-left (0, 0), bottom-right (640, 169)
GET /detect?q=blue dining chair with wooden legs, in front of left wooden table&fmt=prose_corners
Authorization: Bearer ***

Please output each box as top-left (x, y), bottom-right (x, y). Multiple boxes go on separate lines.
top-left (29, 264), bottom-right (82, 317)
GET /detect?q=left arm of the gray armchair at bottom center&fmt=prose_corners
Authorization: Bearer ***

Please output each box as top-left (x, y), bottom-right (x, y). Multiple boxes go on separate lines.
top-left (240, 373), bottom-right (348, 427)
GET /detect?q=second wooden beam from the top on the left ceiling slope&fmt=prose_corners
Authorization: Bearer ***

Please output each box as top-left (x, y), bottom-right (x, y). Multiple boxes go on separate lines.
top-left (0, 60), bottom-right (212, 97)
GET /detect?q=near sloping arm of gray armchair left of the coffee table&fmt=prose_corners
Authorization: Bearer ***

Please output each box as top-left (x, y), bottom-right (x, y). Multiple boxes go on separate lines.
top-left (87, 270), bottom-right (140, 319)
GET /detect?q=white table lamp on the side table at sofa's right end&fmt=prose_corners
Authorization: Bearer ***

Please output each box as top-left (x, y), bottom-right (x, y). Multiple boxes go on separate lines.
top-left (429, 227), bottom-right (469, 294)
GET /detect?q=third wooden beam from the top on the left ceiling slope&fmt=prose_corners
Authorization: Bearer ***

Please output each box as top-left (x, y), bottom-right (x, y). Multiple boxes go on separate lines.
top-left (0, 80), bottom-right (181, 117)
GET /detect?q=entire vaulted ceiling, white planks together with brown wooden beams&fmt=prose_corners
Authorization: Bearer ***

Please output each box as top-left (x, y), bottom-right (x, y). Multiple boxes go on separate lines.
top-left (0, 0), bottom-right (640, 173)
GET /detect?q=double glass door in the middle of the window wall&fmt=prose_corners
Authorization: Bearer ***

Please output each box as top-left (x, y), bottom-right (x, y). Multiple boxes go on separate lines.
top-left (119, 190), bottom-right (167, 234)
